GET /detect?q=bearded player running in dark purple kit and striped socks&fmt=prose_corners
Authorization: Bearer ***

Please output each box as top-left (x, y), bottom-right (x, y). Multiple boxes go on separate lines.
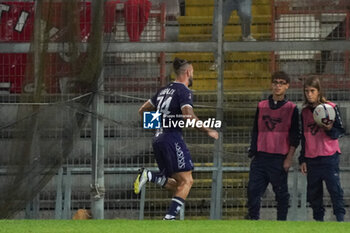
top-left (134, 58), bottom-right (219, 220)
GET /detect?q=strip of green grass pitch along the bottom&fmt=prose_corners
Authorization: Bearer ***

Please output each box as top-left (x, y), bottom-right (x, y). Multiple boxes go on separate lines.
top-left (0, 220), bottom-right (350, 233)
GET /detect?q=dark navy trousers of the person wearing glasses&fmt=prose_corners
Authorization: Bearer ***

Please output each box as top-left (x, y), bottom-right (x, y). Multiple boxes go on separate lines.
top-left (248, 156), bottom-right (289, 220)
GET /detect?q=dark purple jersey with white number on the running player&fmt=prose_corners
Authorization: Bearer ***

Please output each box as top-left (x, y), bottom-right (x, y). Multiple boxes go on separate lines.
top-left (150, 82), bottom-right (193, 132)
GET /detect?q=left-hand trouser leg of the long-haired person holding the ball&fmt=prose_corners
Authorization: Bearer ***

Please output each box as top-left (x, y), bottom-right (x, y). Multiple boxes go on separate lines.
top-left (306, 164), bottom-right (325, 221)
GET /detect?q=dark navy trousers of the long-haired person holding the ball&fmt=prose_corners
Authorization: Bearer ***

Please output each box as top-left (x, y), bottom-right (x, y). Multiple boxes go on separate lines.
top-left (306, 154), bottom-right (345, 221)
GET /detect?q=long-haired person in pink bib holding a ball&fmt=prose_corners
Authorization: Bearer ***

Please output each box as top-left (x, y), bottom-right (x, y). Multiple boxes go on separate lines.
top-left (299, 76), bottom-right (345, 222)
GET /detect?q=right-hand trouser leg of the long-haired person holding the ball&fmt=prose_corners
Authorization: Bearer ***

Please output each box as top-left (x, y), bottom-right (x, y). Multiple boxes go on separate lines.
top-left (324, 155), bottom-right (345, 222)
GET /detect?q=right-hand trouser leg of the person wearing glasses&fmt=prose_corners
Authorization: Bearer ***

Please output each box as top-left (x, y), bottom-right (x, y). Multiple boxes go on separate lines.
top-left (269, 158), bottom-right (290, 221)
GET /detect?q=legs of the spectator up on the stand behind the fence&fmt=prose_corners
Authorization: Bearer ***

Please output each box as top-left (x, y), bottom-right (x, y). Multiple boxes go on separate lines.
top-left (210, 0), bottom-right (256, 70)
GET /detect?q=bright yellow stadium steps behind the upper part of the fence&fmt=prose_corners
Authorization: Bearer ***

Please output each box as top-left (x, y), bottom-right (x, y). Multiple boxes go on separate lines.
top-left (174, 0), bottom-right (272, 91)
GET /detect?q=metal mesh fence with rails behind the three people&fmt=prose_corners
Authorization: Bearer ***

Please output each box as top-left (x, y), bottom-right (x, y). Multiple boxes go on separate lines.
top-left (0, 0), bottom-right (350, 220)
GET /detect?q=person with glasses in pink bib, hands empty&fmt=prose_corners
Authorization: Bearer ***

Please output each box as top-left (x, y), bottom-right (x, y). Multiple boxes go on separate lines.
top-left (248, 71), bottom-right (300, 220)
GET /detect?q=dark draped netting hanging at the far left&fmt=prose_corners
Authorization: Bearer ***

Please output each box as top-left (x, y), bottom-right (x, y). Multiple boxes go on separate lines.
top-left (1, 1), bottom-right (103, 218)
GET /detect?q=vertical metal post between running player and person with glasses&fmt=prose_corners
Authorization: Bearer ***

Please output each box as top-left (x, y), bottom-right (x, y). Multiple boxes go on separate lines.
top-left (210, 0), bottom-right (224, 219)
